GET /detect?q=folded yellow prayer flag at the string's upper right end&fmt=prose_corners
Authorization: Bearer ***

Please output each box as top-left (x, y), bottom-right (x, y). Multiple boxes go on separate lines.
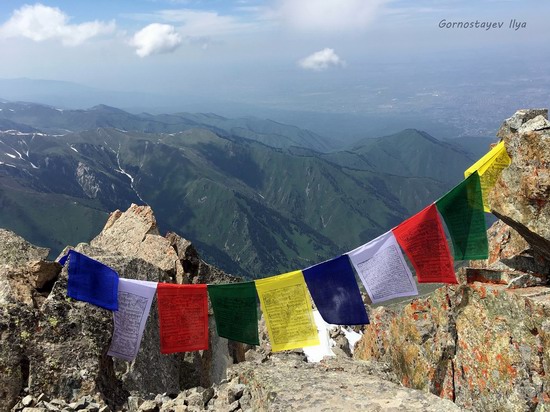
top-left (464, 141), bottom-right (512, 213)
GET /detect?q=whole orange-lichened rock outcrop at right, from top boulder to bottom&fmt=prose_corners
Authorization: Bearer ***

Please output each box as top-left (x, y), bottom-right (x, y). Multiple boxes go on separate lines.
top-left (355, 110), bottom-right (550, 411)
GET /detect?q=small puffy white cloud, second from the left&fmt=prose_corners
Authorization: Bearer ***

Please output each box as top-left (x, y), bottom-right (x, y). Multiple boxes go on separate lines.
top-left (131, 23), bottom-right (181, 57)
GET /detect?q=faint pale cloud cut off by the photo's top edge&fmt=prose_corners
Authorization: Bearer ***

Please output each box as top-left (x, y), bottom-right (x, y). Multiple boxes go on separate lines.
top-left (278, 0), bottom-right (389, 31)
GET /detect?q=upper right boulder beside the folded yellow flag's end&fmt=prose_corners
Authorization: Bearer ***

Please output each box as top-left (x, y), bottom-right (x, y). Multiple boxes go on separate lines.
top-left (489, 110), bottom-right (550, 260)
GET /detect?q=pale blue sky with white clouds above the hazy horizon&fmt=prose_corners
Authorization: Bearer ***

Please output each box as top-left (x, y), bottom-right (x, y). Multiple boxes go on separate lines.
top-left (0, 0), bottom-right (550, 138)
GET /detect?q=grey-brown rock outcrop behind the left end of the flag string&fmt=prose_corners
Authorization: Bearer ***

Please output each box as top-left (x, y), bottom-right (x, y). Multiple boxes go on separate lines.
top-left (0, 205), bottom-right (245, 410)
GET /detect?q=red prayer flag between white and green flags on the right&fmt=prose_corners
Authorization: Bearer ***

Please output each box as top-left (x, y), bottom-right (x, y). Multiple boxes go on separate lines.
top-left (392, 204), bottom-right (458, 283)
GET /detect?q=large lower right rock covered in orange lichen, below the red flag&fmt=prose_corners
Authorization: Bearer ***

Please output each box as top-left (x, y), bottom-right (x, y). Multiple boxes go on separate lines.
top-left (354, 282), bottom-right (550, 411)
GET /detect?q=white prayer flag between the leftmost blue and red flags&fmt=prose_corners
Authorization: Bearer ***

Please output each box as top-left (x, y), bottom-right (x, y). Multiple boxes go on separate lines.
top-left (107, 279), bottom-right (157, 362)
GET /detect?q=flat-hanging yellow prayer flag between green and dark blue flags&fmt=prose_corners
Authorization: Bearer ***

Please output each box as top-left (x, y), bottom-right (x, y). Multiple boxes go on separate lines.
top-left (255, 270), bottom-right (319, 352)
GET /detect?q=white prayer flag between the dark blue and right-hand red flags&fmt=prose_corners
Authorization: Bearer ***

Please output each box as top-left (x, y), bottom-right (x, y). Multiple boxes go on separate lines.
top-left (348, 231), bottom-right (418, 303)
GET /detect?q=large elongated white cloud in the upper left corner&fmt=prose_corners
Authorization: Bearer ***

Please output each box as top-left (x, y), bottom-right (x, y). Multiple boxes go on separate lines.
top-left (0, 3), bottom-right (116, 46)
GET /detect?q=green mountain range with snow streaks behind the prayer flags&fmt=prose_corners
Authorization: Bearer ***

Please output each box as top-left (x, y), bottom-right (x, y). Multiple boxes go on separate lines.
top-left (0, 102), bottom-right (496, 278)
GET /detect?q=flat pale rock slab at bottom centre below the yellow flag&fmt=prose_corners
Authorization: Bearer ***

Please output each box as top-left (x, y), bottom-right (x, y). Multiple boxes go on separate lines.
top-left (232, 356), bottom-right (459, 412)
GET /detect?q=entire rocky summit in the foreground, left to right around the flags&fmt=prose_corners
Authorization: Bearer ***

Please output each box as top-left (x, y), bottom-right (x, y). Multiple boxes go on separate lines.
top-left (0, 110), bottom-right (550, 412)
